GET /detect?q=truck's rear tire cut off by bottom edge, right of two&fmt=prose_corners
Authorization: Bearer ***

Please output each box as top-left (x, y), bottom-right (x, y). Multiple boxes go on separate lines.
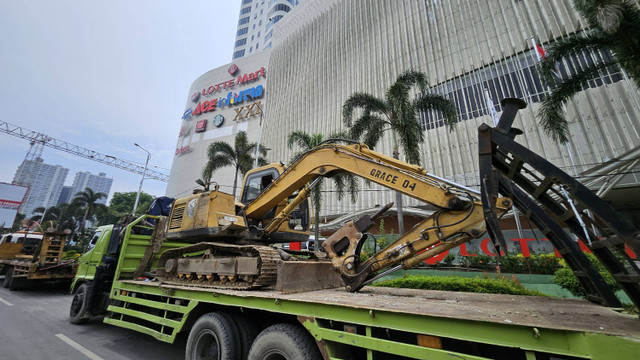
top-left (248, 324), bottom-right (322, 360)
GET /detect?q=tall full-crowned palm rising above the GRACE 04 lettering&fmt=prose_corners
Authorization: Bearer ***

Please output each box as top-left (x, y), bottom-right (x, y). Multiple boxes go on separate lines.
top-left (342, 70), bottom-right (457, 233)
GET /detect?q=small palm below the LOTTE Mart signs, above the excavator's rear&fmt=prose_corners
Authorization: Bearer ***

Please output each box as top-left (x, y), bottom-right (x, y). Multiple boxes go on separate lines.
top-left (202, 131), bottom-right (267, 197)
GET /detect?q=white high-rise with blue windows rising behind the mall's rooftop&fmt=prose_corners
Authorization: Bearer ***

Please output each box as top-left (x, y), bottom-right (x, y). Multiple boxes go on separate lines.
top-left (233, 0), bottom-right (300, 59)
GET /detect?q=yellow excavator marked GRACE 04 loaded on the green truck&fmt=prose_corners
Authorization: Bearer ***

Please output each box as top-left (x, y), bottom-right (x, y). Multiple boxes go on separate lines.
top-left (160, 143), bottom-right (511, 291)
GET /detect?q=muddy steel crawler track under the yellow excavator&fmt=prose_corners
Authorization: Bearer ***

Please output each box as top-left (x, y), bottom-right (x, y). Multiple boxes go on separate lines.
top-left (156, 242), bottom-right (280, 290)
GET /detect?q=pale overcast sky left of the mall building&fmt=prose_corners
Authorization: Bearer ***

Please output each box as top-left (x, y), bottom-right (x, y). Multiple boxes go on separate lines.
top-left (0, 0), bottom-right (240, 202)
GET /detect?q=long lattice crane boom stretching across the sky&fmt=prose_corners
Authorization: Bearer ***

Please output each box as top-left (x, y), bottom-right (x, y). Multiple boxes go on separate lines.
top-left (0, 121), bottom-right (169, 182)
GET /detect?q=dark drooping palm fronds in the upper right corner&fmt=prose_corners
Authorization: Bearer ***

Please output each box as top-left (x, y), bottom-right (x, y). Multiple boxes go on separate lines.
top-left (538, 0), bottom-right (640, 143)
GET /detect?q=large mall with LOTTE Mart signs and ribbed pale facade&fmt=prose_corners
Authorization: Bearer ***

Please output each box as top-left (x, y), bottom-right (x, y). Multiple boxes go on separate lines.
top-left (167, 0), bottom-right (640, 229)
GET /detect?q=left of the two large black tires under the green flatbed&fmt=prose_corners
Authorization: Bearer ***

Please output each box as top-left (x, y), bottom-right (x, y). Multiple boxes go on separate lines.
top-left (184, 312), bottom-right (240, 360)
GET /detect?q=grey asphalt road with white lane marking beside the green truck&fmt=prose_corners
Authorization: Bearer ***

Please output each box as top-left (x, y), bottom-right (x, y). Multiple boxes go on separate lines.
top-left (0, 278), bottom-right (186, 360)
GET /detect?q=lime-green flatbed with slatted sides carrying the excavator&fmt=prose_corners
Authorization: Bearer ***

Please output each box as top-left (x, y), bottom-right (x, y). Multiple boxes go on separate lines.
top-left (72, 217), bottom-right (640, 360)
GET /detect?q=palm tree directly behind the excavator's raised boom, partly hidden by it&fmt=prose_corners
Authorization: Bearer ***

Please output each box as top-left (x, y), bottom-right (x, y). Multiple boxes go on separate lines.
top-left (287, 131), bottom-right (358, 251)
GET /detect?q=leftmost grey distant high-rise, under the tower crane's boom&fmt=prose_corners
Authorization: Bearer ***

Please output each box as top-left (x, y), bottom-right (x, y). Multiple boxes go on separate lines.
top-left (13, 158), bottom-right (69, 217)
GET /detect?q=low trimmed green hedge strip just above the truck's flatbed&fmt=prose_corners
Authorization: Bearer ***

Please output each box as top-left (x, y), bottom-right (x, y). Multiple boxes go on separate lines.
top-left (374, 275), bottom-right (547, 296)
